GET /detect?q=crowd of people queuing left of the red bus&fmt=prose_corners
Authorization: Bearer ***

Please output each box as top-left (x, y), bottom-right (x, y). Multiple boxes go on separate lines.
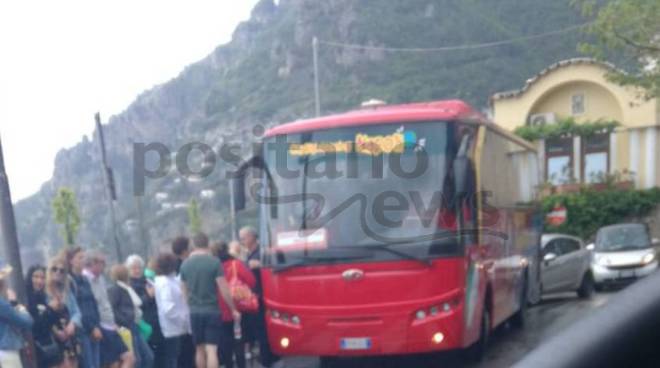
top-left (0, 227), bottom-right (278, 368)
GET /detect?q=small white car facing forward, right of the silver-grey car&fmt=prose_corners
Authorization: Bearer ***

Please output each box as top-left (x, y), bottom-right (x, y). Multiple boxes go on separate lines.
top-left (591, 224), bottom-right (658, 289)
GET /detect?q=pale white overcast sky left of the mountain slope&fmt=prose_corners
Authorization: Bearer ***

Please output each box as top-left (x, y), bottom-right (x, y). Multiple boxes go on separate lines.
top-left (0, 0), bottom-right (257, 202)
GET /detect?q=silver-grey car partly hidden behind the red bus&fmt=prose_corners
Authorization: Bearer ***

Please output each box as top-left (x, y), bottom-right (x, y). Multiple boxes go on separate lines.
top-left (541, 234), bottom-right (594, 298)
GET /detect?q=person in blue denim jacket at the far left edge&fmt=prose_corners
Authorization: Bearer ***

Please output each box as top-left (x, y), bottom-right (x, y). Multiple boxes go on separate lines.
top-left (0, 260), bottom-right (32, 368)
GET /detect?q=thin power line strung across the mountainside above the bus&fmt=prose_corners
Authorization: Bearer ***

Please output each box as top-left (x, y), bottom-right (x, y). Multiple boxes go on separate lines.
top-left (317, 23), bottom-right (590, 52)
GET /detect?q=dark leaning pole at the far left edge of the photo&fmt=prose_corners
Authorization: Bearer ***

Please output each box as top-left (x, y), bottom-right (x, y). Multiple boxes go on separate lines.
top-left (0, 134), bottom-right (27, 303)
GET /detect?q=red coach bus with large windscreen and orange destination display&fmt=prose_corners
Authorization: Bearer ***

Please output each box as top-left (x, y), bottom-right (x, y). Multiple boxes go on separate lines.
top-left (234, 100), bottom-right (541, 357)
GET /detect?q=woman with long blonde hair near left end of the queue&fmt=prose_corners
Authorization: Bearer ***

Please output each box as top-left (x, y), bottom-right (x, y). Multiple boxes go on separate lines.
top-left (46, 257), bottom-right (80, 368)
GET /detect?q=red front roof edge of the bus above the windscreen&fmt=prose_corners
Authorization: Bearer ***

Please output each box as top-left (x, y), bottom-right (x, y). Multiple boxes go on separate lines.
top-left (266, 100), bottom-right (488, 137)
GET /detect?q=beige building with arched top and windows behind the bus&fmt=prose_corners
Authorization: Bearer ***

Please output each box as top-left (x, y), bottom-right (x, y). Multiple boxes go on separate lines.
top-left (491, 58), bottom-right (660, 188)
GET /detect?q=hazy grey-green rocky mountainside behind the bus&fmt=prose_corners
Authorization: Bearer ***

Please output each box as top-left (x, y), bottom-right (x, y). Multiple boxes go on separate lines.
top-left (16, 0), bottom-right (582, 262)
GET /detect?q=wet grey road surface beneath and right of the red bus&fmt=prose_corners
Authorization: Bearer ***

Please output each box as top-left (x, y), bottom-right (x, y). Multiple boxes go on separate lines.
top-left (252, 292), bottom-right (616, 368)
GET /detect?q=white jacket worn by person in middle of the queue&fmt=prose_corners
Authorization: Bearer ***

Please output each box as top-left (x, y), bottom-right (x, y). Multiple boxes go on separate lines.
top-left (154, 274), bottom-right (190, 337)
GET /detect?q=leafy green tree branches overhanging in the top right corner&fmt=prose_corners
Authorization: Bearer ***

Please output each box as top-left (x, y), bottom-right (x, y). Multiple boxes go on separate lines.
top-left (573, 0), bottom-right (660, 99)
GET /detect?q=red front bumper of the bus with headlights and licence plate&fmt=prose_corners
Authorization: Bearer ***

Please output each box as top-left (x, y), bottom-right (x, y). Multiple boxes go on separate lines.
top-left (266, 305), bottom-right (464, 356)
